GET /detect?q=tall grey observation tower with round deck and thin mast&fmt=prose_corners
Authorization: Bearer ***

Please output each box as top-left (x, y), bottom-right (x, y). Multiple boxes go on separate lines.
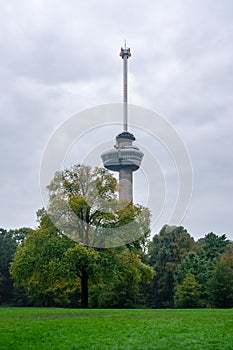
top-left (101, 44), bottom-right (143, 201)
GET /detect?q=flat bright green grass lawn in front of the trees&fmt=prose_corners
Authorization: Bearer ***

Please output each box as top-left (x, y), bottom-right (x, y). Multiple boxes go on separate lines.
top-left (0, 308), bottom-right (233, 350)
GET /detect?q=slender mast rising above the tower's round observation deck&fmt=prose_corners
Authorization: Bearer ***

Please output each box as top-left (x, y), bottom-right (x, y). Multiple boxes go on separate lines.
top-left (120, 40), bottom-right (131, 132)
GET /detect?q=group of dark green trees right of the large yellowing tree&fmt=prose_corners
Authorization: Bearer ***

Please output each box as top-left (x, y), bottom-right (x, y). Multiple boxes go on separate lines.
top-left (146, 226), bottom-right (233, 308)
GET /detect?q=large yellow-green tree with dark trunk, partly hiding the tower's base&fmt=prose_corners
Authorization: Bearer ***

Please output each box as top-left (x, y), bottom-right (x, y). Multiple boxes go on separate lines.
top-left (11, 165), bottom-right (150, 307)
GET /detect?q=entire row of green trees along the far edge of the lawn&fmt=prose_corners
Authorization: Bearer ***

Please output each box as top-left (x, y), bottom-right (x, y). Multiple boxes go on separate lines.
top-left (0, 165), bottom-right (233, 308)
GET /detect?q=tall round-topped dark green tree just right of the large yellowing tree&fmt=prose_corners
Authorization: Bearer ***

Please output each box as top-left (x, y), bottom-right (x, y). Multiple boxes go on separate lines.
top-left (148, 225), bottom-right (196, 307)
